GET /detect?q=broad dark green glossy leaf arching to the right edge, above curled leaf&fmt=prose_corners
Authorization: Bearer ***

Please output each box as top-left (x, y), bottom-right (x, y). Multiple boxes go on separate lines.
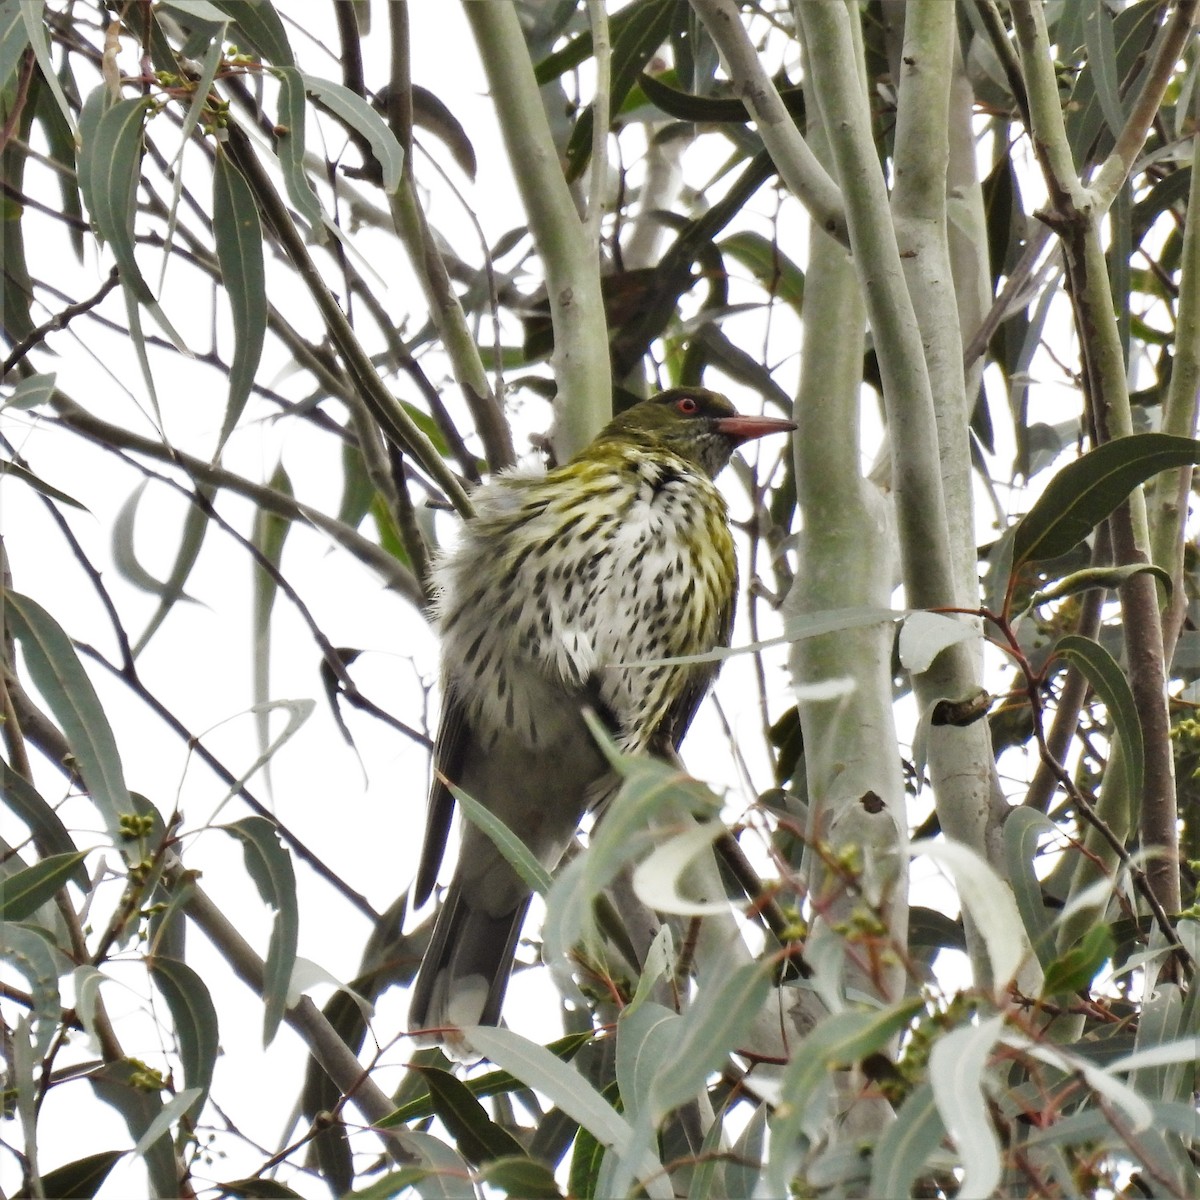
top-left (1013, 433), bottom-right (1200, 570)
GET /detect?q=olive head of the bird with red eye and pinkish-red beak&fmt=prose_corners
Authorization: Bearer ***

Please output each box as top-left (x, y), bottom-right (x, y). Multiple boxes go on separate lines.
top-left (593, 388), bottom-right (796, 476)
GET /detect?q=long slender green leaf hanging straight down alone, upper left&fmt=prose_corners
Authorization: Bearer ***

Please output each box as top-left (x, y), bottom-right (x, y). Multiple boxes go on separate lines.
top-left (212, 148), bottom-right (266, 454)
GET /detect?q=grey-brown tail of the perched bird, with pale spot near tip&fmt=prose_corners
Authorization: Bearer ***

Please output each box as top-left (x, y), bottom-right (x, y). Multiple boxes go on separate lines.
top-left (408, 880), bottom-right (529, 1040)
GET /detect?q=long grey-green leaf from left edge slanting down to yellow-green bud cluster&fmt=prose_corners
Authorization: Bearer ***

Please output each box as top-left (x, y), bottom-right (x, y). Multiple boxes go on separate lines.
top-left (7, 592), bottom-right (133, 847)
